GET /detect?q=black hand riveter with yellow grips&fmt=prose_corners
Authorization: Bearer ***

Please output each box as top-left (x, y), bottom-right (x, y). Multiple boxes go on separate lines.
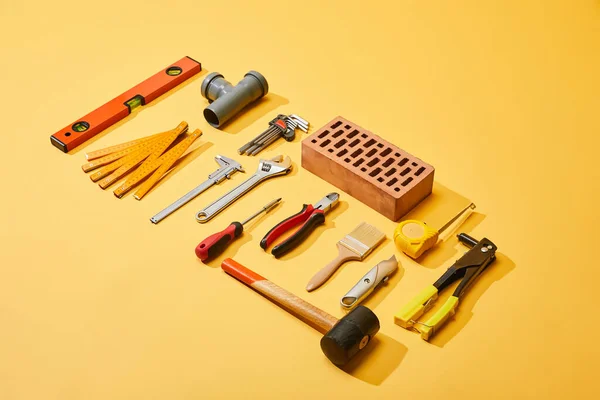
top-left (394, 233), bottom-right (497, 340)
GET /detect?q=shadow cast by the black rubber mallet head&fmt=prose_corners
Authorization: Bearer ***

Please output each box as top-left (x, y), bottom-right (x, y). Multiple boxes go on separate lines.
top-left (342, 333), bottom-right (408, 386)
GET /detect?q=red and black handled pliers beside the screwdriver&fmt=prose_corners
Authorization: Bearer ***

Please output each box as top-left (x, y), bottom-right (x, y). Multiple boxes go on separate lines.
top-left (260, 193), bottom-right (340, 258)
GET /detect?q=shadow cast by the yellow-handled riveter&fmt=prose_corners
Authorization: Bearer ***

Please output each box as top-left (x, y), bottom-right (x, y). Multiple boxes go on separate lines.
top-left (412, 253), bottom-right (516, 348)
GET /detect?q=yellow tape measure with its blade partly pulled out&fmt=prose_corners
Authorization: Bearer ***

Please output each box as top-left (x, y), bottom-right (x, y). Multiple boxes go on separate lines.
top-left (394, 203), bottom-right (475, 259)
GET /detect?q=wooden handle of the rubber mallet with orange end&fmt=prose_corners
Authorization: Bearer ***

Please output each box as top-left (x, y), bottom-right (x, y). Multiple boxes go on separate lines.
top-left (221, 258), bottom-right (338, 334)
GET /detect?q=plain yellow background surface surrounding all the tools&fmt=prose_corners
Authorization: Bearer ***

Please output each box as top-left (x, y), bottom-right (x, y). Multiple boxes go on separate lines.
top-left (0, 0), bottom-right (600, 400)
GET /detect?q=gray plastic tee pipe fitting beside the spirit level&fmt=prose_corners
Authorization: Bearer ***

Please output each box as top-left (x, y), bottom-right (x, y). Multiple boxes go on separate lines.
top-left (201, 71), bottom-right (269, 128)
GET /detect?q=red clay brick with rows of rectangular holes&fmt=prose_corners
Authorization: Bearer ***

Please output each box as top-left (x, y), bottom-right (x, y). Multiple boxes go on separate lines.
top-left (302, 117), bottom-right (435, 221)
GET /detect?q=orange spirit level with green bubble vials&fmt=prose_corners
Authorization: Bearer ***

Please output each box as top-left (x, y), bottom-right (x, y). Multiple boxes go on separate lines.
top-left (50, 57), bottom-right (202, 153)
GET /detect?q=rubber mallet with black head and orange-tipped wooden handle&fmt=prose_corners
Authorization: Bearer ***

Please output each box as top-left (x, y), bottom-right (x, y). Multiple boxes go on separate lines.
top-left (221, 258), bottom-right (379, 366)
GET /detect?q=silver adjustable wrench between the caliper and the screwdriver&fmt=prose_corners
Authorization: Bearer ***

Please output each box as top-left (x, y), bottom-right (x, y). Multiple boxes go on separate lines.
top-left (196, 155), bottom-right (292, 223)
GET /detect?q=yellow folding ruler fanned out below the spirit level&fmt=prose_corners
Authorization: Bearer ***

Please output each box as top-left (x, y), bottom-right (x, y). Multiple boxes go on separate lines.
top-left (81, 121), bottom-right (202, 200)
